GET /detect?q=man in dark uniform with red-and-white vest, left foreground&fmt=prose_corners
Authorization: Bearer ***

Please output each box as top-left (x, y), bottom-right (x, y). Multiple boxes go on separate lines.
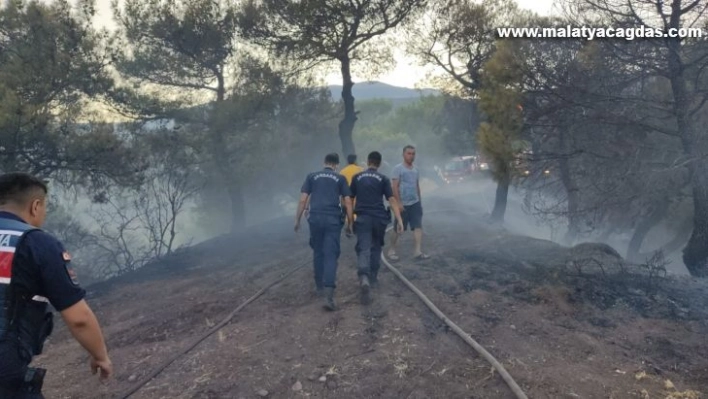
top-left (0, 173), bottom-right (113, 399)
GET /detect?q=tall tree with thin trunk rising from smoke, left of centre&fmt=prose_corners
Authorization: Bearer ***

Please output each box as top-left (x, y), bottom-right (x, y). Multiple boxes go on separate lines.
top-left (113, 0), bottom-right (258, 229)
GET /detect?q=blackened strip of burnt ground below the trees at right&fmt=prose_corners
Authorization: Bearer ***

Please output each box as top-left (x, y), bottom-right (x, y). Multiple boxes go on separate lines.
top-left (454, 245), bottom-right (708, 321)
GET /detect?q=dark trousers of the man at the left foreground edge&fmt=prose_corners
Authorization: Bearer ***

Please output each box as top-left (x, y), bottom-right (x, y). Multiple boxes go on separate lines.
top-left (0, 341), bottom-right (44, 399)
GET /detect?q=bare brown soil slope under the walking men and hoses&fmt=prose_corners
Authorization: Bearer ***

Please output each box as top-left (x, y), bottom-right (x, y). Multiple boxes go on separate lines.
top-left (36, 195), bottom-right (708, 399)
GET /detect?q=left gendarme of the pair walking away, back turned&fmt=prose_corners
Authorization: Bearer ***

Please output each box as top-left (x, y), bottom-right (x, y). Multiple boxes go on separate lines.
top-left (295, 154), bottom-right (354, 310)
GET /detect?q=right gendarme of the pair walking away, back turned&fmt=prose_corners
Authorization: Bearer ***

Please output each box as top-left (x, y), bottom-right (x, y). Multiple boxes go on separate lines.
top-left (351, 151), bottom-right (403, 303)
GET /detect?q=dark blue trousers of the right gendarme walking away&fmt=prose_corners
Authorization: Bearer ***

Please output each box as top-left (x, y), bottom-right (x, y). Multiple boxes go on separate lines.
top-left (354, 215), bottom-right (388, 278)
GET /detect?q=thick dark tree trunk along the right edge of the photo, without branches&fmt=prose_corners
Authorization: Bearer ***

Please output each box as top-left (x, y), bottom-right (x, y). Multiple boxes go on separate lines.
top-left (666, 0), bottom-right (708, 277)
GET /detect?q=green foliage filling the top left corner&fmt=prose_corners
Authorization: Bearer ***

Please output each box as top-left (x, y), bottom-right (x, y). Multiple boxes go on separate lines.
top-left (0, 0), bottom-right (139, 186)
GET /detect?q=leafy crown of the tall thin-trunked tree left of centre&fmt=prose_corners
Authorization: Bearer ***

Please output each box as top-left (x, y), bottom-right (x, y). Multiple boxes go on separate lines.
top-left (113, 0), bottom-right (237, 100)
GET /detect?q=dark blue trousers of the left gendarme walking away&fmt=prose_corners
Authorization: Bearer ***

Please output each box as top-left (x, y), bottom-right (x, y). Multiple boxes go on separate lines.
top-left (307, 213), bottom-right (344, 288)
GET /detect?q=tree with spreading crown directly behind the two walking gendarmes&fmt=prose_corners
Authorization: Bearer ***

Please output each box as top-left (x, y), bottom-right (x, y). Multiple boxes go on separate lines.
top-left (241, 0), bottom-right (426, 154)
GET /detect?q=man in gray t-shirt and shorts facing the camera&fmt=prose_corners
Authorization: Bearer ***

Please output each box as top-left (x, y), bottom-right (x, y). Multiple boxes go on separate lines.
top-left (388, 145), bottom-right (430, 261)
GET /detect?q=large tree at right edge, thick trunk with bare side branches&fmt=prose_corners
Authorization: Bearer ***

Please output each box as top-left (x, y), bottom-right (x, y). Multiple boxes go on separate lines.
top-left (571, 0), bottom-right (708, 276)
